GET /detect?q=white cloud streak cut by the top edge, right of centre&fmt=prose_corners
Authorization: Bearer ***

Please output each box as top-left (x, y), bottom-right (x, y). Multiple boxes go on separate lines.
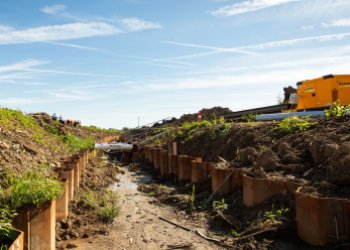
top-left (210, 0), bottom-right (302, 17)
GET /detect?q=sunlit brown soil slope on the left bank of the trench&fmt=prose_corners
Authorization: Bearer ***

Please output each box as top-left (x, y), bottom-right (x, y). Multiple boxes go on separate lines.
top-left (0, 113), bottom-right (115, 181)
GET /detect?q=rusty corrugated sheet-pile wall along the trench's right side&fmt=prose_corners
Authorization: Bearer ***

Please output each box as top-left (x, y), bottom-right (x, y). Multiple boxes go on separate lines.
top-left (133, 143), bottom-right (350, 246)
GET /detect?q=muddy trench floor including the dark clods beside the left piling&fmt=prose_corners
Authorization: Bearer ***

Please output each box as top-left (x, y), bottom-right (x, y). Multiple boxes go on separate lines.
top-left (57, 158), bottom-right (226, 250)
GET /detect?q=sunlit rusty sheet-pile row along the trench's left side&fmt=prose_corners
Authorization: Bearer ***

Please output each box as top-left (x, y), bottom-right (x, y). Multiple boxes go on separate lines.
top-left (9, 149), bottom-right (96, 250)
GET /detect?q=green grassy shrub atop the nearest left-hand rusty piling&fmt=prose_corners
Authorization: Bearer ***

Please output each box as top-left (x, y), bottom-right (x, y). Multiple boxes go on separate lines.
top-left (4, 167), bottom-right (64, 208)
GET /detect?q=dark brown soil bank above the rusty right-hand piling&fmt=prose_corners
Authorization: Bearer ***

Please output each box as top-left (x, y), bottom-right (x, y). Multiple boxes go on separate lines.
top-left (178, 118), bottom-right (350, 198)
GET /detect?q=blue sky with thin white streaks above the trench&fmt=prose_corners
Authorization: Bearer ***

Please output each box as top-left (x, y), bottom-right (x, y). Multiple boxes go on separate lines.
top-left (0, 0), bottom-right (350, 128)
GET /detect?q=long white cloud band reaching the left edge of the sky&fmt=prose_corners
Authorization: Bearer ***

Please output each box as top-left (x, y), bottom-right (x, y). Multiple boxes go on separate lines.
top-left (0, 22), bottom-right (120, 44)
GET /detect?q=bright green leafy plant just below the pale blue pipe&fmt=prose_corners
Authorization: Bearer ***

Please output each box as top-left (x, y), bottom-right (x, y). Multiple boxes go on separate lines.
top-left (277, 116), bottom-right (317, 134)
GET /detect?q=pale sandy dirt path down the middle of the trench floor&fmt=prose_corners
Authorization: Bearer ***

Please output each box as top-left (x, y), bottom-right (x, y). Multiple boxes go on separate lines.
top-left (72, 165), bottom-right (223, 250)
